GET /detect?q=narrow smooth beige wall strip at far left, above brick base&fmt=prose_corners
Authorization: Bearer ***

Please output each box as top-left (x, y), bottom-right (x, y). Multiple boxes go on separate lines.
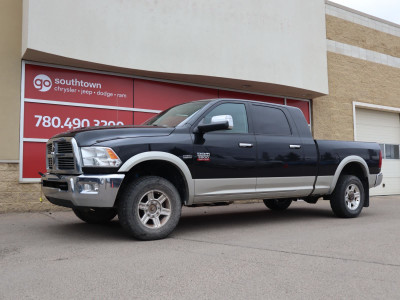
top-left (0, 0), bottom-right (22, 164)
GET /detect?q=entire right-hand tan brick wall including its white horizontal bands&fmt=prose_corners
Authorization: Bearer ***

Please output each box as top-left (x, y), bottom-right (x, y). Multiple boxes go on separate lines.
top-left (313, 3), bottom-right (400, 140)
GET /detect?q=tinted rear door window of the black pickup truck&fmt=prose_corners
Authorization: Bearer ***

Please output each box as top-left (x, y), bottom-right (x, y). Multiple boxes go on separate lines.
top-left (252, 105), bottom-right (291, 135)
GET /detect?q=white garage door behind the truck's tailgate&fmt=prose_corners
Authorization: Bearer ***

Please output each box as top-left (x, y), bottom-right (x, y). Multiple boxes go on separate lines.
top-left (356, 108), bottom-right (400, 195)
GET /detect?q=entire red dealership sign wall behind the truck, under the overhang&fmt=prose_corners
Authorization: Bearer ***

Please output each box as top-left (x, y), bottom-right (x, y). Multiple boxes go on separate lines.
top-left (20, 61), bottom-right (311, 182)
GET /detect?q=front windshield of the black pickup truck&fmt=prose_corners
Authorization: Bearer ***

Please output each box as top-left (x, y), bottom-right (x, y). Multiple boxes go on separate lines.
top-left (143, 101), bottom-right (209, 127)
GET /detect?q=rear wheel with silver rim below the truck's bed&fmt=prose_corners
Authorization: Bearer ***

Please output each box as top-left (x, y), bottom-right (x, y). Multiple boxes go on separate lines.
top-left (330, 175), bottom-right (365, 218)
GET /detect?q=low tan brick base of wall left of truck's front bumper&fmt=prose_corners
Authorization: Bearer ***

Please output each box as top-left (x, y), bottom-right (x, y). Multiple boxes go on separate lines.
top-left (0, 163), bottom-right (64, 213)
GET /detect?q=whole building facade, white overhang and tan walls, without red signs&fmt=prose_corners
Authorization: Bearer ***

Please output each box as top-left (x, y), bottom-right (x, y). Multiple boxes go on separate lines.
top-left (0, 0), bottom-right (400, 212)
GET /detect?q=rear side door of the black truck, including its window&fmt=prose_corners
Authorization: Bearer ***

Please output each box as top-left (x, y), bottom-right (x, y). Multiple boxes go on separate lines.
top-left (251, 104), bottom-right (315, 198)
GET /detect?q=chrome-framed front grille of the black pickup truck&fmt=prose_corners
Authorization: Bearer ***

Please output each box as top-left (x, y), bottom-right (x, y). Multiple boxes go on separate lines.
top-left (47, 138), bottom-right (80, 174)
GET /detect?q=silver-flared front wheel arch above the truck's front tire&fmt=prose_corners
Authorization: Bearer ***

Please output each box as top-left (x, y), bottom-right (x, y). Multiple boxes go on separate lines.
top-left (118, 151), bottom-right (194, 205)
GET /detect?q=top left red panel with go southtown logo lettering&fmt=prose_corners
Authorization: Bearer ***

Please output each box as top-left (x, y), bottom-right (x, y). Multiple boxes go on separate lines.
top-left (25, 64), bottom-right (133, 107)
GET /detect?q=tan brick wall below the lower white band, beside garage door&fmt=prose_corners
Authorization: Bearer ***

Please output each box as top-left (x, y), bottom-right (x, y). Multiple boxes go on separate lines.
top-left (313, 51), bottom-right (400, 141)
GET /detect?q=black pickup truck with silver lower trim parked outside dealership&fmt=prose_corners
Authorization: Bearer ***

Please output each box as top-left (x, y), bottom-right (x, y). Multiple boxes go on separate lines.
top-left (42, 99), bottom-right (382, 240)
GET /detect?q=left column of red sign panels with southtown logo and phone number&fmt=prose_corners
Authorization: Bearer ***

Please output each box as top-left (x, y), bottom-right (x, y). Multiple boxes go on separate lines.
top-left (20, 62), bottom-right (134, 182)
